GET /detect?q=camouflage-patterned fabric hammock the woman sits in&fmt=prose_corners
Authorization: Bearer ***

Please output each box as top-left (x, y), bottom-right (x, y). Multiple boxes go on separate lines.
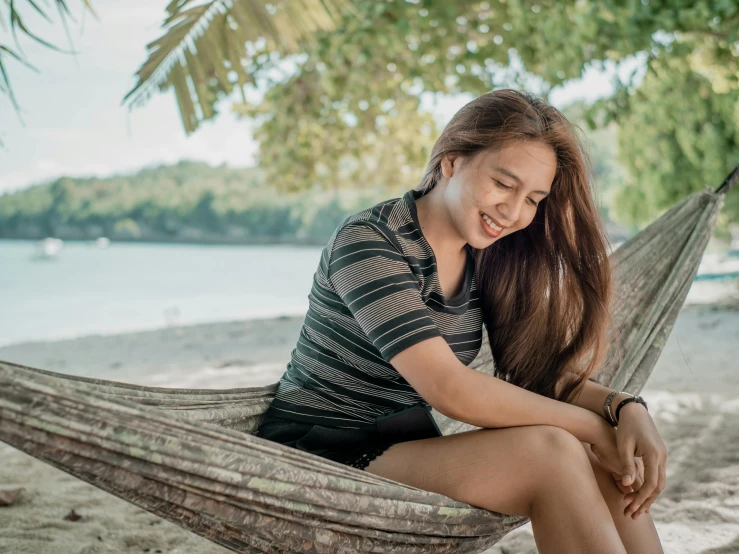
top-left (0, 167), bottom-right (739, 554)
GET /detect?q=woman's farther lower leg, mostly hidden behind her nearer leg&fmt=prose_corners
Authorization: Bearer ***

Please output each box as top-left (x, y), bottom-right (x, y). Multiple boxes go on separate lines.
top-left (582, 443), bottom-right (664, 554)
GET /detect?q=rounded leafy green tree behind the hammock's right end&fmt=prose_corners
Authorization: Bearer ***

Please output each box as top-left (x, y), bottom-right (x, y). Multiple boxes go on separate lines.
top-left (596, 44), bottom-right (739, 234)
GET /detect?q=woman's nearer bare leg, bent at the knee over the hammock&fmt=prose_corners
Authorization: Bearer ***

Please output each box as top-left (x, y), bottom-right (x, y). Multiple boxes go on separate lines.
top-left (366, 425), bottom-right (627, 554)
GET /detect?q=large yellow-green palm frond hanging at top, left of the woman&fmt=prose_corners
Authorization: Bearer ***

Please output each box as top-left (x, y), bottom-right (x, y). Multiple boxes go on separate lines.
top-left (122, 0), bottom-right (351, 133)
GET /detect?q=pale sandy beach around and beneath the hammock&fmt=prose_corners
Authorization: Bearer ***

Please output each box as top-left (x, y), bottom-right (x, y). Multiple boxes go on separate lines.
top-left (0, 296), bottom-right (739, 554)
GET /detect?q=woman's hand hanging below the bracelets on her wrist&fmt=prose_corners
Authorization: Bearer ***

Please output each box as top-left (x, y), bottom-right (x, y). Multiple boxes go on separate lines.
top-left (616, 402), bottom-right (667, 519)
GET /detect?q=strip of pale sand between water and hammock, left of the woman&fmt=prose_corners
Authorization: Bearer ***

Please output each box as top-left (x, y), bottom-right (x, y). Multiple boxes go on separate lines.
top-left (0, 316), bottom-right (305, 388)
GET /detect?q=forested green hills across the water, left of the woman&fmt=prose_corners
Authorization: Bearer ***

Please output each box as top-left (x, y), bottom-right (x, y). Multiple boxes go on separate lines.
top-left (0, 162), bottom-right (404, 244)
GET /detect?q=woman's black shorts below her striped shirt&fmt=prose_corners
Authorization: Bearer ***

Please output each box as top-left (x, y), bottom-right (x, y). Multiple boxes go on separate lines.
top-left (255, 416), bottom-right (394, 469)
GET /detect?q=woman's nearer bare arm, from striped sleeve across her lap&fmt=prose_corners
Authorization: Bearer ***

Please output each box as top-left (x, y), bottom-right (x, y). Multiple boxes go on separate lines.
top-left (390, 337), bottom-right (610, 443)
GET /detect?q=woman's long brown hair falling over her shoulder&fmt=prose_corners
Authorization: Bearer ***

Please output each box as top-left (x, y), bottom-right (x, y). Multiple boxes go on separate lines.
top-left (416, 89), bottom-right (612, 402)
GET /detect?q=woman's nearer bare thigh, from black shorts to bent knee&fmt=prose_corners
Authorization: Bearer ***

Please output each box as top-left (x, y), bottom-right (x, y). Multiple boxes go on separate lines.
top-left (365, 425), bottom-right (592, 516)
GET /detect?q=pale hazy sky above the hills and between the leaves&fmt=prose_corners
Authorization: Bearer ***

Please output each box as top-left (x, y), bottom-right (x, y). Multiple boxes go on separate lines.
top-left (0, 0), bottom-right (639, 194)
